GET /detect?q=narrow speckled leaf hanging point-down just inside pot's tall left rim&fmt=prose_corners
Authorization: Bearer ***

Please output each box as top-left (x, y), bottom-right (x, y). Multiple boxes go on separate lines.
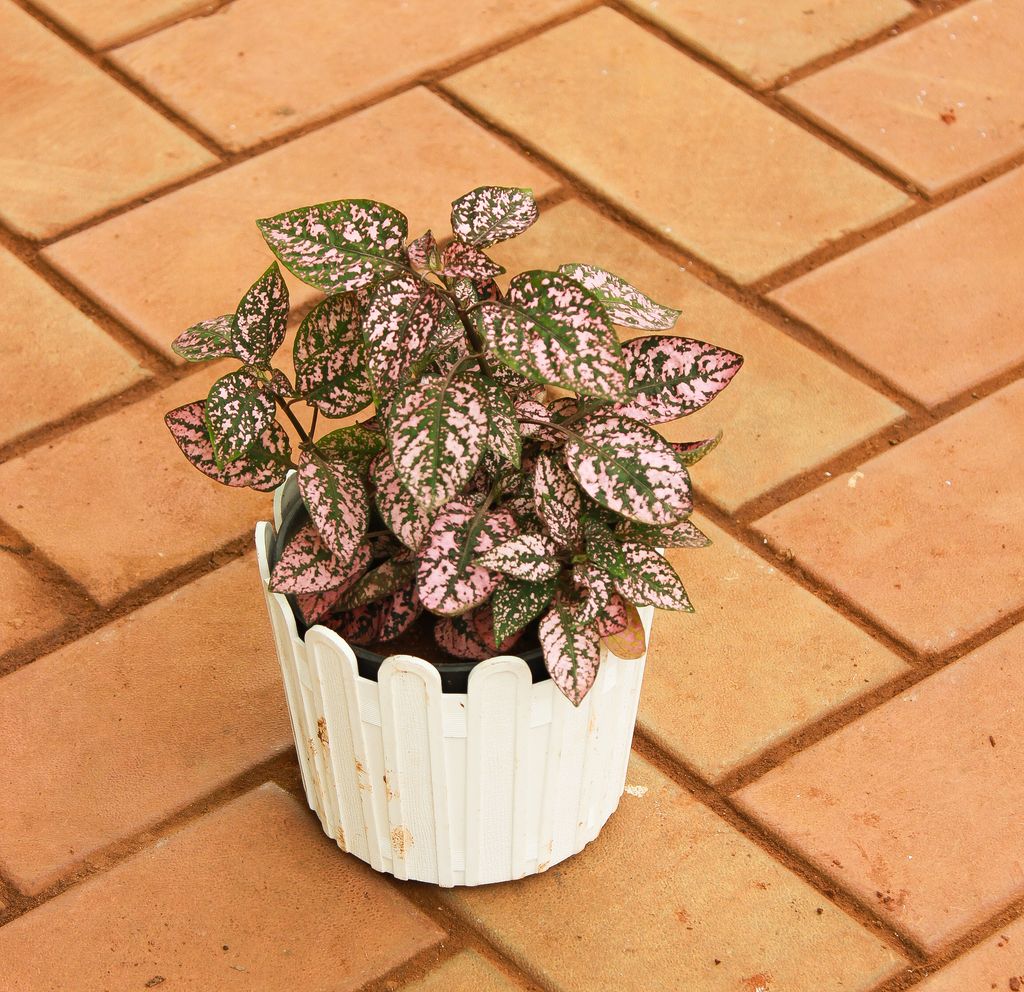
top-left (299, 451), bottom-right (370, 561)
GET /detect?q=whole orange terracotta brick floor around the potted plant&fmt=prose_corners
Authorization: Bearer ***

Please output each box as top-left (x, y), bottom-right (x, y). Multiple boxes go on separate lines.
top-left (0, 0), bottom-right (1024, 992)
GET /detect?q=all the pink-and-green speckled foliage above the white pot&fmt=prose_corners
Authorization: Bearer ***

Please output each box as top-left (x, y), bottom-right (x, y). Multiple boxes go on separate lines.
top-left (166, 186), bottom-right (742, 704)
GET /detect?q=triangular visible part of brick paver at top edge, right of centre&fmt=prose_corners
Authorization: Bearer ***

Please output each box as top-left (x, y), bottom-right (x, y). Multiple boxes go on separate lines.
top-left (626, 0), bottom-right (913, 89)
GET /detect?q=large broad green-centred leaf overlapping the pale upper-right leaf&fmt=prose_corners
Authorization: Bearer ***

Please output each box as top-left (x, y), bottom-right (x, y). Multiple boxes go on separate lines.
top-left (470, 270), bottom-right (626, 399)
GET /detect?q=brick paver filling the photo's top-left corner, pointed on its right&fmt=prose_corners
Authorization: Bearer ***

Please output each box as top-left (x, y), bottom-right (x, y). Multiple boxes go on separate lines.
top-left (0, 0), bottom-right (216, 238)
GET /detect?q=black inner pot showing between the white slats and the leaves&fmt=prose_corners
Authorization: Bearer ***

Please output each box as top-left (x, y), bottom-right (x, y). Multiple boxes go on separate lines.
top-left (270, 477), bottom-right (549, 692)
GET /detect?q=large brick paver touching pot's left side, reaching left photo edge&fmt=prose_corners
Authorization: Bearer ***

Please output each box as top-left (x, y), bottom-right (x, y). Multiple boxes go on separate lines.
top-left (0, 557), bottom-right (291, 893)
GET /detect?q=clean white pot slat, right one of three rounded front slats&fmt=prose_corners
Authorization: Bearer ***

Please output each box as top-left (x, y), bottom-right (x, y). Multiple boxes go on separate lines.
top-left (466, 657), bottom-right (532, 886)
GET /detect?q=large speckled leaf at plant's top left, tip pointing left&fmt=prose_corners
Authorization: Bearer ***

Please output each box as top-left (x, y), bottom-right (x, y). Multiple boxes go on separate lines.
top-left (256, 200), bottom-right (409, 294)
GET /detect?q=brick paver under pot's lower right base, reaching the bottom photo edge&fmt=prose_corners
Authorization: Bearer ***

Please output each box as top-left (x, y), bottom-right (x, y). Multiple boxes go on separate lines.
top-left (447, 758), bottom-right (900, 992)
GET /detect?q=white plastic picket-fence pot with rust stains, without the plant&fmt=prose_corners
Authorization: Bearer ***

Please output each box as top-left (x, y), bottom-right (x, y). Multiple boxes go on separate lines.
top-left (256, 477), bottom-right (653, 887)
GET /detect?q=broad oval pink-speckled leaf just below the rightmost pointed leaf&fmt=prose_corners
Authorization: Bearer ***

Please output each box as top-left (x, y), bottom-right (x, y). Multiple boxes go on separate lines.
top-left (565, 413), bottom-right (693, 524)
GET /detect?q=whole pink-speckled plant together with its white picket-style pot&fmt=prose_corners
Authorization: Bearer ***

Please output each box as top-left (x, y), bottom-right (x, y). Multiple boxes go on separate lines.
top-left (166, 186), bottom-right (742, 886)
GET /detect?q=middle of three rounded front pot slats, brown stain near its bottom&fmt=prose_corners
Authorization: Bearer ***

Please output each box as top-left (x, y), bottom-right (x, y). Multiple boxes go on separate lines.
top-left (378, 654), bottom-right (454, 886)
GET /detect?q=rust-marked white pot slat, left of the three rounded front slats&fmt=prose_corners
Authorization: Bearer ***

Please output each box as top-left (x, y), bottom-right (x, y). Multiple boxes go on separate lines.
top-left (306, 627), bottom-right (381, 870)
